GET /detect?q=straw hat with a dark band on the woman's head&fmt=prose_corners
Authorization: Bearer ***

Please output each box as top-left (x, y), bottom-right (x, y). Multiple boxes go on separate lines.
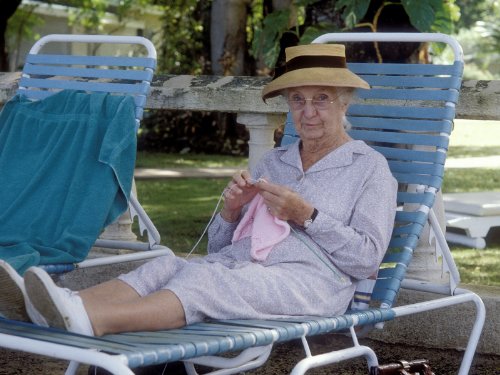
top-left (262, 44), bottom-right (370, 101)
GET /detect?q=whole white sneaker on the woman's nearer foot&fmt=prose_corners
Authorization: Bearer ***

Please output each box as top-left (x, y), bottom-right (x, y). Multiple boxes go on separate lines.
top-left (24, 267), bottom-right (94, 336)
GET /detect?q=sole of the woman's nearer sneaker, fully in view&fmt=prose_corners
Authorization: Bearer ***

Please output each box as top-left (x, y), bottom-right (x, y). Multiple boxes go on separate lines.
top-left (24, 269), bottom-right (68, 330)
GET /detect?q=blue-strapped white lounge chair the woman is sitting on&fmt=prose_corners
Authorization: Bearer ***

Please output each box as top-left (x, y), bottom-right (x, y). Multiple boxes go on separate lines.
top-left (0, 34), bottom-right (485, 375)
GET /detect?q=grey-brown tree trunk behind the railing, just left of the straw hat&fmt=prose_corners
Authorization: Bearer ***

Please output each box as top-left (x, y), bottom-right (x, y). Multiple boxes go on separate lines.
top-left (210, 0), bottom-right (251, 76)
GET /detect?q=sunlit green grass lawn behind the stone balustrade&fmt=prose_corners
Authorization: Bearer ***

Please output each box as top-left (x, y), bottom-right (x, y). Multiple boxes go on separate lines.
top-left (133, 121), bottom-right (500, 286)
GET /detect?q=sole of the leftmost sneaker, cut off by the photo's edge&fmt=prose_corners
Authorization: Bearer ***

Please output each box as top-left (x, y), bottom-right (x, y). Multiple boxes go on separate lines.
top-left (0, 264), bottom-right (31, 322)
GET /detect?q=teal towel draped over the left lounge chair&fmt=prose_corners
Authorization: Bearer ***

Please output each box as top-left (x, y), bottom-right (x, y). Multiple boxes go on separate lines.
top-left (0, 90), bottom-right (136, 274)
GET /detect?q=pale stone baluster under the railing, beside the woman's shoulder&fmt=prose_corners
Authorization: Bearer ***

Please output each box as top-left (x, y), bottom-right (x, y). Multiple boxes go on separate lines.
top-left (236, 113), bottom-right (285, 170)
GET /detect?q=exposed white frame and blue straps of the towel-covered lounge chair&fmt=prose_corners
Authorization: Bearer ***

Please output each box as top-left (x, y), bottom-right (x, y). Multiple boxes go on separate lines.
top-left (17, 34), bottom-right (170, 273)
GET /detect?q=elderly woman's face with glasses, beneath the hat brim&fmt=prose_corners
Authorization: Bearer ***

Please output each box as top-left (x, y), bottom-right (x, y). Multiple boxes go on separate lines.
top-left (286, 86), bottom-right (347, 142)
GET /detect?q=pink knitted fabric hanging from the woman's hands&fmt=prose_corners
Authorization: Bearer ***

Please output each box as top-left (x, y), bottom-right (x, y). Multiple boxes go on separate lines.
top-left (233, 195), bottom-right (290, 261)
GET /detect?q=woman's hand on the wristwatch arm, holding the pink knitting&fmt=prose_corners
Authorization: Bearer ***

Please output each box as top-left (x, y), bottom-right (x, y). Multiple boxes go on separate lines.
top-left (257, 180), bottom-right (314, 225)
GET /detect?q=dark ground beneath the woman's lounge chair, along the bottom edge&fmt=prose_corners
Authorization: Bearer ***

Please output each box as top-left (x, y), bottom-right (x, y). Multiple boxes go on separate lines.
top-left (0, 335), bottom-right (500, 375)
